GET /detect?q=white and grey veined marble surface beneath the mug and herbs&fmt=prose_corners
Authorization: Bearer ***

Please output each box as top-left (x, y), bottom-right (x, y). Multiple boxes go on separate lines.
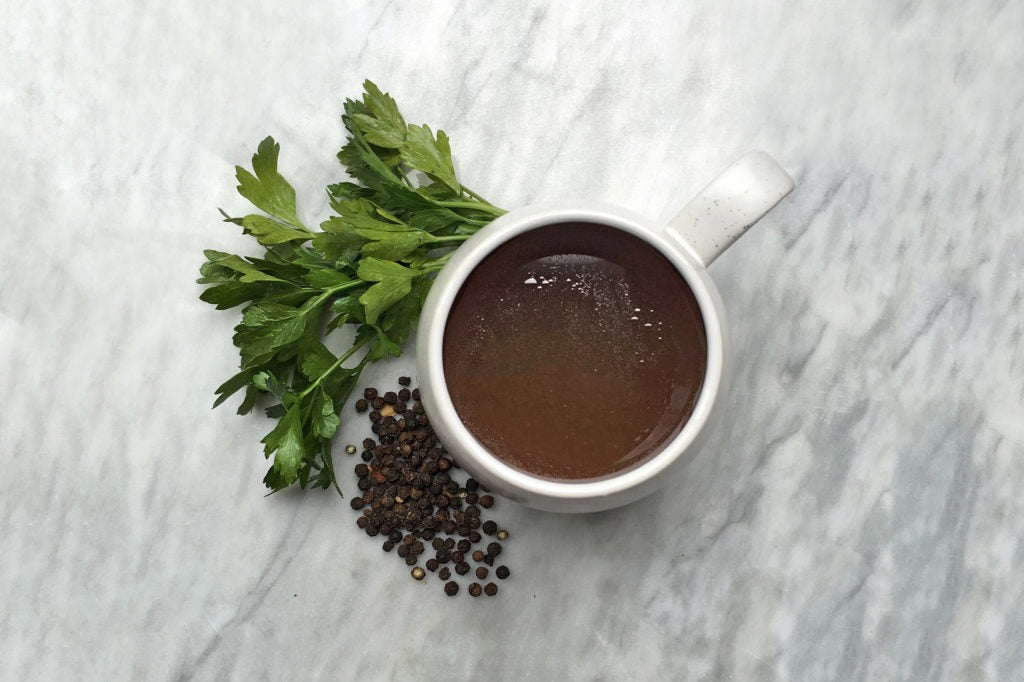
top-left (0, 0), bottom-right (1024, 680)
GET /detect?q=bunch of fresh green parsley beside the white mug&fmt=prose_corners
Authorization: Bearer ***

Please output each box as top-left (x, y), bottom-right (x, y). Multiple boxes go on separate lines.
top-left (198, 81), bottom-right (504, 494)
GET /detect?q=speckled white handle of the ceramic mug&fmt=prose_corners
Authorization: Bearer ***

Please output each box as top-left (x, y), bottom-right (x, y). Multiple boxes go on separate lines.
top-left (668, 152), bottom-right (796, 266)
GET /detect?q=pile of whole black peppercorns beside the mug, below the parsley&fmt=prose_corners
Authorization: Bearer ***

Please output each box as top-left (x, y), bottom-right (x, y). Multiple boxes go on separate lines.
top-left (346, 377), bottom-right (509, 597)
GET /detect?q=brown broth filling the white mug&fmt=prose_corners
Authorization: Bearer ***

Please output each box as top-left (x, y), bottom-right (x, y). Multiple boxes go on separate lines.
top-left (443, 223), bottom-right (708, 480)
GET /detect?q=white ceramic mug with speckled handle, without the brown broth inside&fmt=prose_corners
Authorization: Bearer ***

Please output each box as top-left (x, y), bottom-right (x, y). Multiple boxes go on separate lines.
top-left (416, 152), bottom-right (794, 512)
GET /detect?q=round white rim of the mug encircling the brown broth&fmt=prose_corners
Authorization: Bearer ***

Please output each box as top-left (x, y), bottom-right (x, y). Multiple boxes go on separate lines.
top-left (417, 202), bottom-right (726, 500)
